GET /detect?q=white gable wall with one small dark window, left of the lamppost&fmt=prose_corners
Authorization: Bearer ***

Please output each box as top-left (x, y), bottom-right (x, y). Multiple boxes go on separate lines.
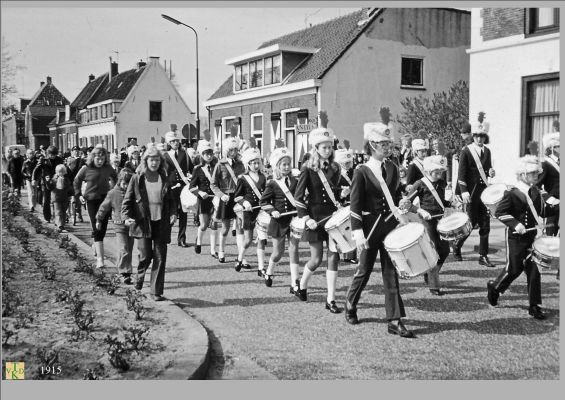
top-left (116, 62), bottom-right (196, 148)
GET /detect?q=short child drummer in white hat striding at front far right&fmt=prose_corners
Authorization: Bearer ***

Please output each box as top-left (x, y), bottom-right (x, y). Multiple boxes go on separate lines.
top-left (487, 155), bottom-right (559, 320)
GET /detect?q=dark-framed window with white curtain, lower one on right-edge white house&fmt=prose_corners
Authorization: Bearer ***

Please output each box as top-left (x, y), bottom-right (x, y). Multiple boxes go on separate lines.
top-left (521, 73), bottom-right (559, 156)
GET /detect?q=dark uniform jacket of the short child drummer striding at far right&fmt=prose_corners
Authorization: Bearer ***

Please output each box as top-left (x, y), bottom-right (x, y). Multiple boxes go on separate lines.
top-left (495, 186), bottom-right (558, 241)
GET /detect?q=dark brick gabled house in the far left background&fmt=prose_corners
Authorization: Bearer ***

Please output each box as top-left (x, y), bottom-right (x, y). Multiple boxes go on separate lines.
top-left (25, 76), bottom-right (70, 150)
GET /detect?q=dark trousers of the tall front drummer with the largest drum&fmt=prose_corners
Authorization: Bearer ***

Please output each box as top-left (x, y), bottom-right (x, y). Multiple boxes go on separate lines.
top-left (346, 215), bottom-right (406, 321)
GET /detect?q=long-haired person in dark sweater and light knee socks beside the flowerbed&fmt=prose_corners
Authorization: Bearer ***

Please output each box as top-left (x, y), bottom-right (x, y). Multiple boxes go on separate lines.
top-left (74, 145), bottom-right (118, 268)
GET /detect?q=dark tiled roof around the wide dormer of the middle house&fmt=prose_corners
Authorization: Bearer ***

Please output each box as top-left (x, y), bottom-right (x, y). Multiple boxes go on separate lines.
top-left (208, 9), bottom-right (379, 100)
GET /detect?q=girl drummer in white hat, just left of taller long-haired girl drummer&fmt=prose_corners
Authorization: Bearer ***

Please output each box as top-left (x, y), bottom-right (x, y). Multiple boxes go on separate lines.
top-left (260, 147), bottom-right (299, 294)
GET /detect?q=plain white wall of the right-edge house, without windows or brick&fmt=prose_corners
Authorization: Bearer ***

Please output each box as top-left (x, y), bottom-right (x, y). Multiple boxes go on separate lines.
top-left (469, 9), bottom-right (559, 184)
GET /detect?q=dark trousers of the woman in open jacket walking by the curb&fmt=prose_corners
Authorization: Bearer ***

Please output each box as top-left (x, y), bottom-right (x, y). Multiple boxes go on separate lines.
top-left (137, 221), bottom-right (167, 295)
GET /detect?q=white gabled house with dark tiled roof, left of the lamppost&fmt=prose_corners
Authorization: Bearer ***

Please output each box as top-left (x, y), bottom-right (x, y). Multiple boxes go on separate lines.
top-left (67, 57), bottom-right (195, 151)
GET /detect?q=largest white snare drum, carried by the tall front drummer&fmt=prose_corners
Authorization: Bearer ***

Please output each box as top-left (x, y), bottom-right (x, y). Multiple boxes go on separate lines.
top-left (384, 222), bottom-right (439, 278)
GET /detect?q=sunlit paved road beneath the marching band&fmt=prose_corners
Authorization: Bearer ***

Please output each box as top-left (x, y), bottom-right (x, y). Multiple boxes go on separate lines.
top-left (27, 195), bottom-right (559, 379)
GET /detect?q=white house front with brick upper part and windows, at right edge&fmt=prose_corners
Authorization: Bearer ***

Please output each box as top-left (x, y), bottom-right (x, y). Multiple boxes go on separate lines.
top-left (468, 8), bottom-right (560, 184)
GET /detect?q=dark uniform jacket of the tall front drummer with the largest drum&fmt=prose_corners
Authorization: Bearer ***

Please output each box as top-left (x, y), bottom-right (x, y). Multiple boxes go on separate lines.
top-left (350, 161), bottom-right (402, 231)
